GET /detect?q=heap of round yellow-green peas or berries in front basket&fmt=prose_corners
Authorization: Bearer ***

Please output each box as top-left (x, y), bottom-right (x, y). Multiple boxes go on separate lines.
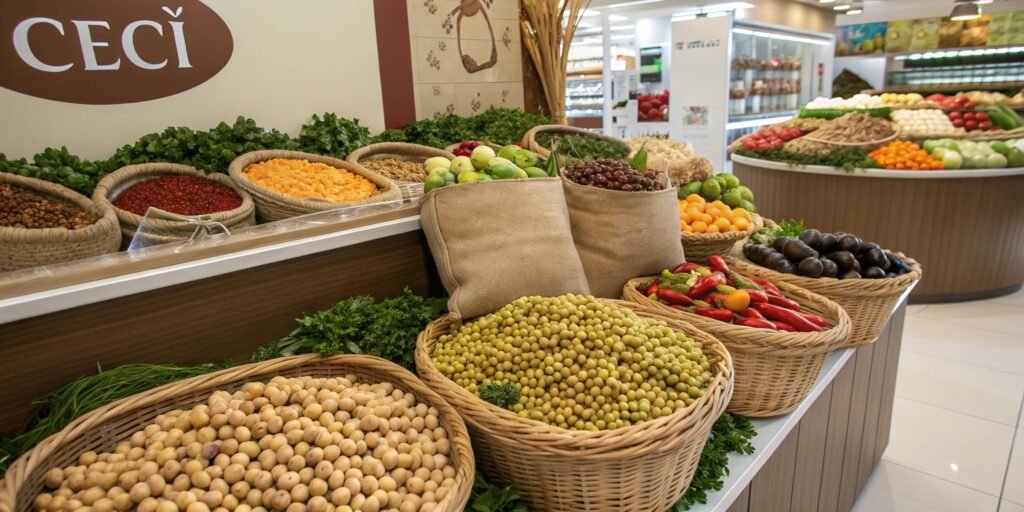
top-left (432, 295), bottom-right (713, 431)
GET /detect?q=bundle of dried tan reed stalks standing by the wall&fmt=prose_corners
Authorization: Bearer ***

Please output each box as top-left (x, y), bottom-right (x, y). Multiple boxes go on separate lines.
top-left (519, 0), bottom-right (590, 124)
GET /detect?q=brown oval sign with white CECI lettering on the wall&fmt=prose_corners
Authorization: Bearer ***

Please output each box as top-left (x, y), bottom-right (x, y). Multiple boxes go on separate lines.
top-left (0, 0), bottom-right (233, 104)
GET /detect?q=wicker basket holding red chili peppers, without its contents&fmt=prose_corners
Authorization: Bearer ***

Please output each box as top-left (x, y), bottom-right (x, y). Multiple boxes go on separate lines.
top-left (623, 276), bottom-right (850, 418)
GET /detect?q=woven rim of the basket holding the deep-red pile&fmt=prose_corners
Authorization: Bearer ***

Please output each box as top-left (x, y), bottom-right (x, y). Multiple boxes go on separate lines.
top-left (92, 162), bottom-right (256, 228)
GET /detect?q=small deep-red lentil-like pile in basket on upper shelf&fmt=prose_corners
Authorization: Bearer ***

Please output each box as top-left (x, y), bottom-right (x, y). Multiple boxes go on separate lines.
top-left (114, 174), bottom-right (242, 215)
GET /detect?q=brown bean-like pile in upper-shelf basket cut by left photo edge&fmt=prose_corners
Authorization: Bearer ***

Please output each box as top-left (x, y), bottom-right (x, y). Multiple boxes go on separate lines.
top-left (0, 183), bottom-right (97, 229)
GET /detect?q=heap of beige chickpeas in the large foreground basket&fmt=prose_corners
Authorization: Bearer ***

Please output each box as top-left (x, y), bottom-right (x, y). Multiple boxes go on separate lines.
top-left (34, 376), bottom-right (456, 512)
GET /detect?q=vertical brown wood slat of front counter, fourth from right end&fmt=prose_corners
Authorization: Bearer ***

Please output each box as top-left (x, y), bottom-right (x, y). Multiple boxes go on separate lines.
top-left (791, 386), bottom-right (831, 511)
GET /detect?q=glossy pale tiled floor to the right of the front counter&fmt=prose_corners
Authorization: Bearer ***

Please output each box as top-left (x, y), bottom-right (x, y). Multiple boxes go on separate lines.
top-left (854, 291), bottom-right (1024, 512)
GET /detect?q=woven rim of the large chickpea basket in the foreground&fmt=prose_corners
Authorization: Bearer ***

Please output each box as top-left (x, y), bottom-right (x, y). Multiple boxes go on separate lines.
top-left (0, 354), bottom-right (476, 512)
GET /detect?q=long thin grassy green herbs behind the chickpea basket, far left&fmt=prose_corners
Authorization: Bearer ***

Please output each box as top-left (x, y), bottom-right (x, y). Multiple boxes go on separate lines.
top-left (0, 361), bottom-right (231, 473)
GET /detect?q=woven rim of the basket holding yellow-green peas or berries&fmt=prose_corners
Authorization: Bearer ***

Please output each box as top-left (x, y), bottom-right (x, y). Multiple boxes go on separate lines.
top-left (416, 299), bottom-right (733, 460)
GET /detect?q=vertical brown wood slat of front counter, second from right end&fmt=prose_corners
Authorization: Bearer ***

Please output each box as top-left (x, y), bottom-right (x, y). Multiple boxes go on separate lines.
top-left (838, 345), bottom-right (874, 511)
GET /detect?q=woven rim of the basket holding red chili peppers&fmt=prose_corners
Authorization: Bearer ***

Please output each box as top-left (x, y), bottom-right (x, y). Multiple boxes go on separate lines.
top-left (623, 270), bottom-right (851, 355)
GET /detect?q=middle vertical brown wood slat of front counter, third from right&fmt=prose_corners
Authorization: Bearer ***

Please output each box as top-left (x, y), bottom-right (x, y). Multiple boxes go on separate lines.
top-left (817, 360), bottom-right (854, 512)
